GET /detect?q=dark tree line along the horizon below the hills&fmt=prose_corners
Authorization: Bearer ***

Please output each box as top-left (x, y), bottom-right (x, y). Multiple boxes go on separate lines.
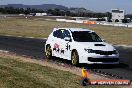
top-left (0, 7), bottom-right (132, 20)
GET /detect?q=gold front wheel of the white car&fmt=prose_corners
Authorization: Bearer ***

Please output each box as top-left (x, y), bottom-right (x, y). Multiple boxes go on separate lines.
top-left (71, 50), bottom-right (79, 66)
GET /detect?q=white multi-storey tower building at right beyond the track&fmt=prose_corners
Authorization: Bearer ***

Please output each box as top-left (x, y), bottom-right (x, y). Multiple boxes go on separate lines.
top-left (111, 9), bottom-right (125, 21)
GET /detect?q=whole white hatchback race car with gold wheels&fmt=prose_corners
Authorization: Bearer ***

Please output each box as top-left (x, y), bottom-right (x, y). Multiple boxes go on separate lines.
top-left (45, 28), bottom-right (119, 65)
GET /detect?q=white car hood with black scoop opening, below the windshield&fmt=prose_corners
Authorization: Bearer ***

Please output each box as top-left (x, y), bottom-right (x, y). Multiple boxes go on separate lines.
top-left (77, 42), bottom-right (114, 51)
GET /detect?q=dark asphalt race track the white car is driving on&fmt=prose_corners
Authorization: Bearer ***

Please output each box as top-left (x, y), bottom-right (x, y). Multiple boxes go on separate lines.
top-left (0, 36), bottom-right (132, 80)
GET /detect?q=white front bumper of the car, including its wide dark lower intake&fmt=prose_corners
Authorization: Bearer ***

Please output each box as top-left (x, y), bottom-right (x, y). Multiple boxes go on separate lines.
top-left (79, 54), bottom-right (119, 64)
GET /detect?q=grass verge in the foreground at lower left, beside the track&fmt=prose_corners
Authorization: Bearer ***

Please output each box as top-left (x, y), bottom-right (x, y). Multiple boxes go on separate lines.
top-left (0, 57), bottom-right (119, 88)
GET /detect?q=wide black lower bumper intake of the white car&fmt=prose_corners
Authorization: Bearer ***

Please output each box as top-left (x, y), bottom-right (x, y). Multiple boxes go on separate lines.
top-left (88, 57), bottom-right (119, 62)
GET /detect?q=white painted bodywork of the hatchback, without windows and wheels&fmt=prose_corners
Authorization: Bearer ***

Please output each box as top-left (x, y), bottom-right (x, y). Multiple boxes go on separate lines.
top-left (45, 28), bottom-right (119, 64)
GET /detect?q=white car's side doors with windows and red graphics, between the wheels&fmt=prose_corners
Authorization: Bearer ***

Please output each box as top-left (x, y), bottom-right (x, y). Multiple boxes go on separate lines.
top-left (53, 29), bottom-right (70, 60)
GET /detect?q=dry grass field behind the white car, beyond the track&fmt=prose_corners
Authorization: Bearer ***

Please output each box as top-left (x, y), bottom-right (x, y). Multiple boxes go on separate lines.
top-left (0, 18), bottom-right (132, 45)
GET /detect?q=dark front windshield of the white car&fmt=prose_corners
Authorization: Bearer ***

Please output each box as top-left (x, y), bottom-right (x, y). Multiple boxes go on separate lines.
top-left (72, 31), bottom-right (102, 42)
